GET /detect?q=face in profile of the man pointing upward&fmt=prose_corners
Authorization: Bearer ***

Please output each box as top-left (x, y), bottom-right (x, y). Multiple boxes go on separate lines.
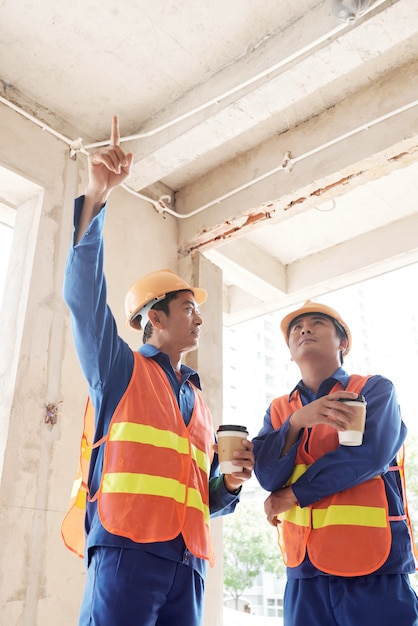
top-left (163, 291), bottom-right (203, 352)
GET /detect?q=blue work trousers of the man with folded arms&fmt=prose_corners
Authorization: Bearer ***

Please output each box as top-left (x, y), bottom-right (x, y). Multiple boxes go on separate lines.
top-left (283, 574), bottom-right (418, 626)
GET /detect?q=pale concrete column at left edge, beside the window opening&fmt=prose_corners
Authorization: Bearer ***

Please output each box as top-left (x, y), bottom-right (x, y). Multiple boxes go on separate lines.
top-left (0, 155), bottom-right (81, 626)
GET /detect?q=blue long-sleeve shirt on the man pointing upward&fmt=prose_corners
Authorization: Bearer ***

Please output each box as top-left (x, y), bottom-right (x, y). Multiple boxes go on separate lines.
top-left (63, 197), bottom-right (239, 577)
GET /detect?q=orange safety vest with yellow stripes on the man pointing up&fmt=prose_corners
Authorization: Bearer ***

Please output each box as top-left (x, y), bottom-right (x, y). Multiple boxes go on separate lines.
top-left (61, 352), bottom-right (214, 564)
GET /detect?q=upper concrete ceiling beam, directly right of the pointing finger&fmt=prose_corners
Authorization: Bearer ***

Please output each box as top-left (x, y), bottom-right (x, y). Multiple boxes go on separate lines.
top-left (130, 2), bottom-right (418, 191)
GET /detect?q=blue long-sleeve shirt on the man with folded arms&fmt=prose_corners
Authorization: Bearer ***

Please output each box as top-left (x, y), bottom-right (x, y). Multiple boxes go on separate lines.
top-left (253, 368), bottom-right (415, 578)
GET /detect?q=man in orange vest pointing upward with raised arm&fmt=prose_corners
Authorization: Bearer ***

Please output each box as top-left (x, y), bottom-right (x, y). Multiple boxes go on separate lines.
top-left (63, 118), bottom-right (254, 626)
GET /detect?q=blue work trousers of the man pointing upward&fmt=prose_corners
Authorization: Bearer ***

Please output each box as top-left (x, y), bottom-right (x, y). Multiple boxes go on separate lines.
top-left (79, 547), bottom-right (204, 626)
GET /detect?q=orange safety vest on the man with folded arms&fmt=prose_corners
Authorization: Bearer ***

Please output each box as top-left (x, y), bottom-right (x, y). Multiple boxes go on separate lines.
top-left (271, 376), bottom-right (405, 576)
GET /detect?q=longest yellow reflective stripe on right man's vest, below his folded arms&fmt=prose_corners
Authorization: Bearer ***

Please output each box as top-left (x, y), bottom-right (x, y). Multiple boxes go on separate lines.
top-left (312, 505), bottom-right (387, 528)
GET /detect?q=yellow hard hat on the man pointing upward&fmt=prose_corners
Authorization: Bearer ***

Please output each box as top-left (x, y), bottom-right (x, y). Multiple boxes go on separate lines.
top-left (125, 270), bottom-right (207, 330)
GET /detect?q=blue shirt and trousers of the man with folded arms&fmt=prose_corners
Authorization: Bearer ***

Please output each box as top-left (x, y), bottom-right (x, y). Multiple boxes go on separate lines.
top-left (253, 368), bottom-right (418, 626)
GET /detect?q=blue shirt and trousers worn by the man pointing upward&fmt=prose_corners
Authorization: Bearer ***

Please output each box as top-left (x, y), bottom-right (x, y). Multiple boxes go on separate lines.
top-left (63, 196), bottom-right (240, 626)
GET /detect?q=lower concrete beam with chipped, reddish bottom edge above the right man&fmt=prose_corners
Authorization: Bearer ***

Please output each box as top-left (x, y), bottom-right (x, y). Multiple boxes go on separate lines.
top-left (177, 55), bottom-right (418, 246)
